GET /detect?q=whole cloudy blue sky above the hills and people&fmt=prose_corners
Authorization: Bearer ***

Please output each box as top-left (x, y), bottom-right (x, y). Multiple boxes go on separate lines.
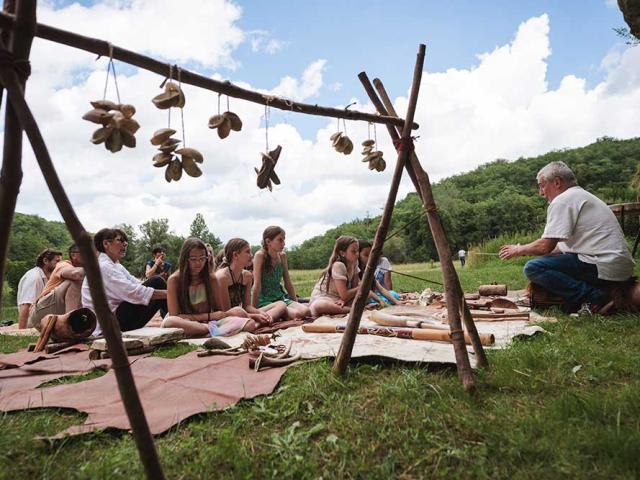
top-left (5, 0), bottom-right (640, 246)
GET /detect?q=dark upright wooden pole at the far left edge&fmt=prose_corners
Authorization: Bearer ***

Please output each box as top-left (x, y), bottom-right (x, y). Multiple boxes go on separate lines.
top-left (0, 0), bottom-right (36, 308)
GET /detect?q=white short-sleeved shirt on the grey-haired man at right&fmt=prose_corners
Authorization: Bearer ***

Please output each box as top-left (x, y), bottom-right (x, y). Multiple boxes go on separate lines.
top-left (542, 186), bottom-right (635, 281)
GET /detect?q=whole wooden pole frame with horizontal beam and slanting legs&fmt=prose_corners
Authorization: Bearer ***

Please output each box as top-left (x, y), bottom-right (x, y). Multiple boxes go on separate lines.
top-left (0, 0), bottom-right (486, 479)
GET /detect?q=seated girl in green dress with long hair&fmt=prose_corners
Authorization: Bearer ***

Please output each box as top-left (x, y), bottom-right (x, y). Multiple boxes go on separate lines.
top-left (253, 226), bottom-right (310, 320)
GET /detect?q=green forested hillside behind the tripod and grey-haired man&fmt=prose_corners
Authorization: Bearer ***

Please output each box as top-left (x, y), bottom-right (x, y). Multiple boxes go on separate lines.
top-left (289, 137), bottom-right (640, 268)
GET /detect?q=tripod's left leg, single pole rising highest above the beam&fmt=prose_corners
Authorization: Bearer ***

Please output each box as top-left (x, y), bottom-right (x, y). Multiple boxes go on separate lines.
top-left (333, 44), bottom-right (428, 375)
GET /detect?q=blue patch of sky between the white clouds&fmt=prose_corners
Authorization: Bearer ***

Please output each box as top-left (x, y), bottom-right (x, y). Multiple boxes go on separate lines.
top-left (62, 0), bottom-right (625, 138)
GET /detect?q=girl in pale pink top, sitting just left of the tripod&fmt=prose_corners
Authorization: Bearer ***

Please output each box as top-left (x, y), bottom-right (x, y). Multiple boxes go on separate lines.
top-left (309, 235), bottom-right (372, 317)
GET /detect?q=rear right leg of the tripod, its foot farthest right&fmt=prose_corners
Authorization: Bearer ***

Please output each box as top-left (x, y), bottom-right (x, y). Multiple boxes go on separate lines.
top-left (372, 77), bottom-right (489, 367)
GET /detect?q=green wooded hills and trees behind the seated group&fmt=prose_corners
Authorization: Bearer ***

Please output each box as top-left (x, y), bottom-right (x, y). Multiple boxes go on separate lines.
top-left (4, 137), bottom-right (640, 303)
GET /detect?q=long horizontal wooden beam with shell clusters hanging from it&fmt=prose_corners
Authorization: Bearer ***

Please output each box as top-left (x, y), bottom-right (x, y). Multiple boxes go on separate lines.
top-left (0, 12), bottom-right (418, 130)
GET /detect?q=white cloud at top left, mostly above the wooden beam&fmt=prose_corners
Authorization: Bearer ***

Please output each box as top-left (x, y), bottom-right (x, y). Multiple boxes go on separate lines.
top-left (32, 0), bottom-right (245, 86)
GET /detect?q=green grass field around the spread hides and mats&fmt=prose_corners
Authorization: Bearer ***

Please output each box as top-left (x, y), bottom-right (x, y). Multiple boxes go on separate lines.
top-left (0, 262), bottom-right (640, 479)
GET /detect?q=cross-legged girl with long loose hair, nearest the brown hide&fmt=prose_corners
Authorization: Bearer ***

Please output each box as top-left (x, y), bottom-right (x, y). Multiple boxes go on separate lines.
top-left (162, 238), bottom-right (257, 337)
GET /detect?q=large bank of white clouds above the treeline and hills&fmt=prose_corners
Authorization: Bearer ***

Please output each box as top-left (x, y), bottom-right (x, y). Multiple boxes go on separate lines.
top-left (7, 9), bottom-right (640, 251)
